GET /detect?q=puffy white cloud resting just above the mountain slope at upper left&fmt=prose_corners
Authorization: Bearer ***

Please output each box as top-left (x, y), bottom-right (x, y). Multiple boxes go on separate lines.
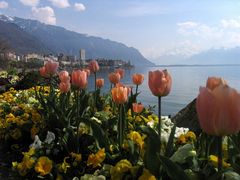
top-left (32, 6), bottom-right (56, 25)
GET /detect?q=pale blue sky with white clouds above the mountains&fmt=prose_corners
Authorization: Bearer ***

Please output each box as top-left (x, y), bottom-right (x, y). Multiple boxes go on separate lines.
top-left (0, 0), bottom-right (240, 63)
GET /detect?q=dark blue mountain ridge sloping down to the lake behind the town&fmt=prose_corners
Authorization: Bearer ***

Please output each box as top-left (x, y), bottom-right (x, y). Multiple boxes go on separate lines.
top-left (0, 15), bottom-right (154, 66)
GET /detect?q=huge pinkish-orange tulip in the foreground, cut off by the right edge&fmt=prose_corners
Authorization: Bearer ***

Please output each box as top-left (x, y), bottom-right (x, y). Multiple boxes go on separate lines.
top-left (196, 83), bottom-right (240, 136)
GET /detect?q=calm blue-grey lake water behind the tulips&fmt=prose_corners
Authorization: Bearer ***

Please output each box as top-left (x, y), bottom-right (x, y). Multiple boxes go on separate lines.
top-left (89, 65), bottom-right (240, 115)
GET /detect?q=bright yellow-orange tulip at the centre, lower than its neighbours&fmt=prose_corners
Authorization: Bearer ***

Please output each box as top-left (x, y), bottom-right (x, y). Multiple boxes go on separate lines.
top-left (111, 87), bottom-right (128, 104)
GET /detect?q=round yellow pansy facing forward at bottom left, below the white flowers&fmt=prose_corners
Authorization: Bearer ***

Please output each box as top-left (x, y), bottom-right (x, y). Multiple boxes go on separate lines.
top-left (35, 156), bottom-right (52, 176)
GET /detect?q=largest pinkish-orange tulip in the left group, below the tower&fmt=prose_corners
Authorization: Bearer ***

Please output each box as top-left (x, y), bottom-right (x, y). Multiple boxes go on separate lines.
top-left (71, 70), bottom-right (87, 89)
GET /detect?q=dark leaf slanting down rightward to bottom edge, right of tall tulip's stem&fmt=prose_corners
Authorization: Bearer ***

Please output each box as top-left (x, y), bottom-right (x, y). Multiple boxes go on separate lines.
top-left (158, 155), bottom-right (190, 180)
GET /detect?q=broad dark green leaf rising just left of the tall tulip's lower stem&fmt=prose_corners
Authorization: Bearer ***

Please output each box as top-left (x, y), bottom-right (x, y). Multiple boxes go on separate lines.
top-left (141, 126), bottom-right (160, 177)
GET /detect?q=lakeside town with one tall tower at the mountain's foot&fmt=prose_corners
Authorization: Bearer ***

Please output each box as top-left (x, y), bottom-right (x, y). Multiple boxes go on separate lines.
top-left (0, 49), bottom-right (133, 69)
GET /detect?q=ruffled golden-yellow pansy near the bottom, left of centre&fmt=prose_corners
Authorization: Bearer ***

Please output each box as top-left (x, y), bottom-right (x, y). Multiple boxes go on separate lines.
top-left (87, 148), bottom-right (106, 168)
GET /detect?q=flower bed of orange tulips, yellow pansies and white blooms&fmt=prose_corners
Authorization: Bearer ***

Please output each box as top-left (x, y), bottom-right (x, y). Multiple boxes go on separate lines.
top-left (0, 61), bottom-right (240, 180)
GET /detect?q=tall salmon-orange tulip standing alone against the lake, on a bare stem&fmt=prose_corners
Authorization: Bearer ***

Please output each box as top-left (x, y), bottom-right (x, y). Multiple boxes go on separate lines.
top-left (148, 70), bottom-right (172, 96)
